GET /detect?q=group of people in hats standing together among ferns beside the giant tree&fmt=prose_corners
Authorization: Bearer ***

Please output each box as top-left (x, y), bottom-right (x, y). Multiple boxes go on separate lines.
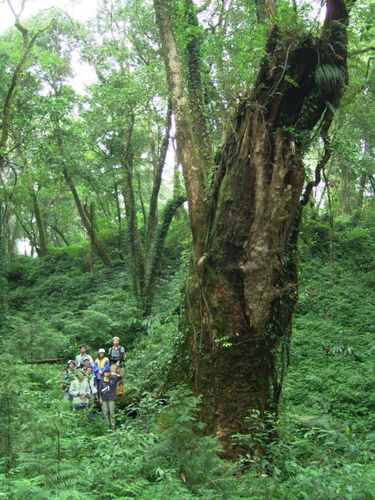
top-left (61, 337), bottom-right (126, 429)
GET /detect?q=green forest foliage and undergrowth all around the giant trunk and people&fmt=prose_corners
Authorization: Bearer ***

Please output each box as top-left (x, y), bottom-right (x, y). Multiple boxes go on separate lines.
top-left (0, 0), bottom-right (375, 500)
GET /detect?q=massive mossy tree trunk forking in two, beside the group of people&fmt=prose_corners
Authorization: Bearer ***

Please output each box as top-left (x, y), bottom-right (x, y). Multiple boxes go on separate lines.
top-left (154, 0), bottom-right (349, 446)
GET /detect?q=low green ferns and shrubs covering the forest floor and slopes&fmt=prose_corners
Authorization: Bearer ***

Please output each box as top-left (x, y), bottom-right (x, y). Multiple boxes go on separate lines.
top-left (0, 211), bottom-right (375, 500)
